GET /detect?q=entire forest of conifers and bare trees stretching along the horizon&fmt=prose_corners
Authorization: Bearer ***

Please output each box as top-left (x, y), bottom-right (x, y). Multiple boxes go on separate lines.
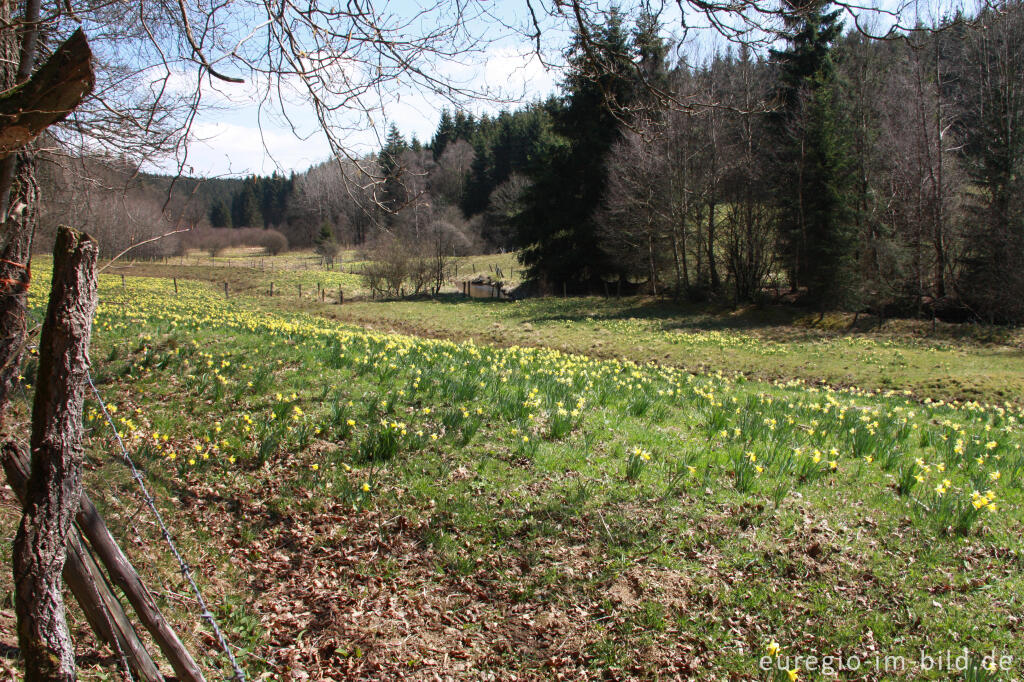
top-left (37, 2), bottom-right (1024, 322)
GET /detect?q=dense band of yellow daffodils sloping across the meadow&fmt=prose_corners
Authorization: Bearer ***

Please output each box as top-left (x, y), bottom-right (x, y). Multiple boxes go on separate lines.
top-left (56, 270), bottom-right (1024, 535)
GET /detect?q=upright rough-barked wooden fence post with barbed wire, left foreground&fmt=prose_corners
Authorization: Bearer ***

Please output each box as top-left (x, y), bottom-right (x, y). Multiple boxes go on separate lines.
top-left (13, 227), bottom-right (98, 682)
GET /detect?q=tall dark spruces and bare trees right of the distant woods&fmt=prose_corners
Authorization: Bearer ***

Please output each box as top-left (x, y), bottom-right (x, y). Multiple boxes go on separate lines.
top-left (489, 2), bottom-right (1024, 322)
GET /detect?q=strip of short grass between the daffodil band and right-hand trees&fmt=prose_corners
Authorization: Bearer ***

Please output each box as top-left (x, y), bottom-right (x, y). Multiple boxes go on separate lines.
top-left (306, 296), bottom-right (1024, 402)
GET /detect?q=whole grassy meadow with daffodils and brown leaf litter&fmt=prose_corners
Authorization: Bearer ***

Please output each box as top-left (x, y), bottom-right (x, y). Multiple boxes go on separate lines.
top-left (2, 251), bottom-right (1024, 680)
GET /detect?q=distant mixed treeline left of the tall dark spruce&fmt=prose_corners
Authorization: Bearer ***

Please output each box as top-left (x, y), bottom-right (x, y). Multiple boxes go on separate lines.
top-left (207, 99), bottom-right (561, 256)
